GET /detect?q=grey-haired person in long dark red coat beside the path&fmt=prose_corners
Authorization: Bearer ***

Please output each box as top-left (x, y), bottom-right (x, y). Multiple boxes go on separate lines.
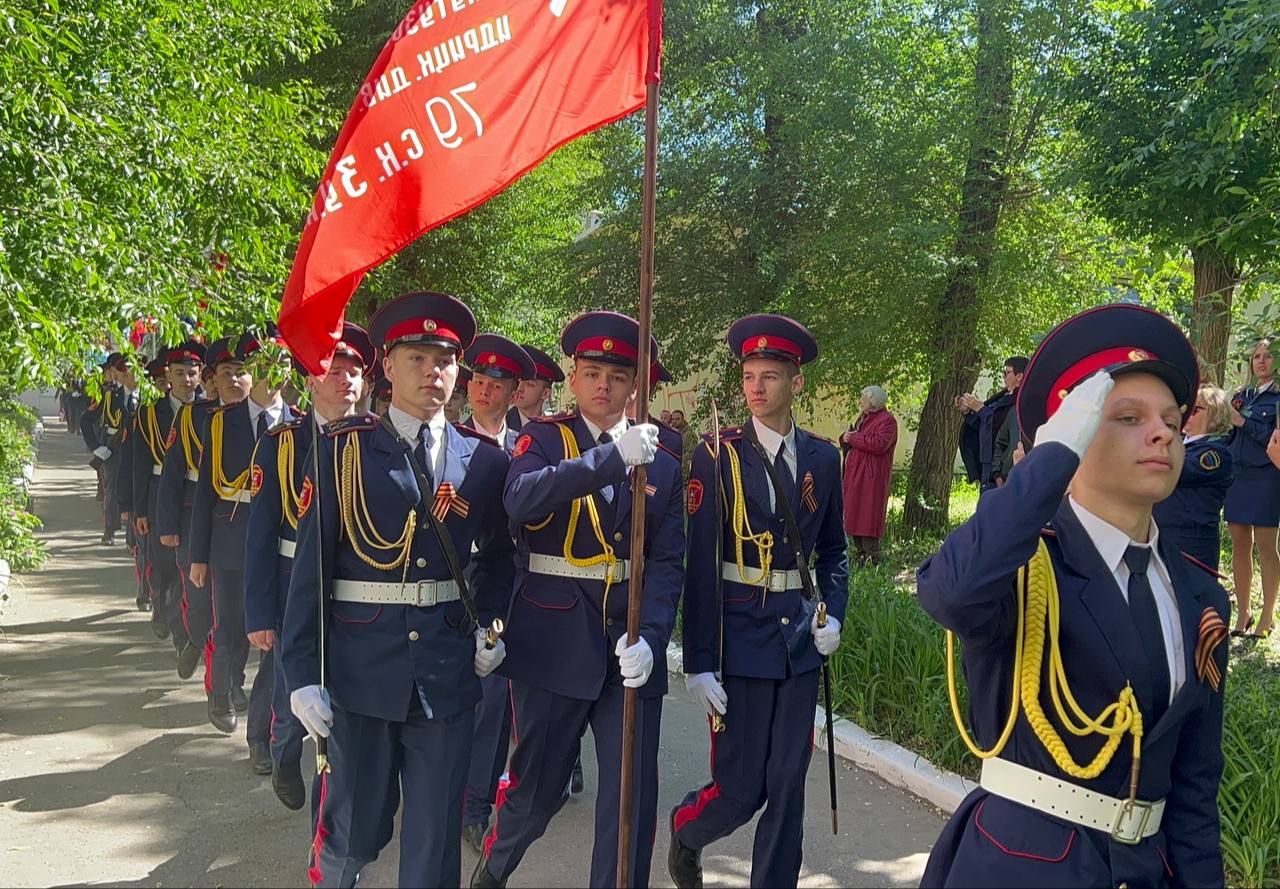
top-left (840, 386), bottom-right (897, 563)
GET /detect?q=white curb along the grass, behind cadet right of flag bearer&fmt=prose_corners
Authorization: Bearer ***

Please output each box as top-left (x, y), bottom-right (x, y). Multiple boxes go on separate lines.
top-left (667, 642), bottom-right (977, 814)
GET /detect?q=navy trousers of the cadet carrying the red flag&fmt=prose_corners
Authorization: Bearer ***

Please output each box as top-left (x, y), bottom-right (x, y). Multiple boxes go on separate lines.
top-left (485, 680), bottom-right (662, 888)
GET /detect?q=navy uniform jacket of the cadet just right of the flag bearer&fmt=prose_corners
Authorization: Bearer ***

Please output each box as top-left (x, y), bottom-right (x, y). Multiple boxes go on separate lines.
top-left (682, 426), bottom-right (849, 679)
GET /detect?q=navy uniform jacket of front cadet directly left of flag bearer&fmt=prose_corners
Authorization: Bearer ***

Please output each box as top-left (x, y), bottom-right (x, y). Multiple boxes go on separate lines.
top-left (282, 416), bottom-right (512, 721)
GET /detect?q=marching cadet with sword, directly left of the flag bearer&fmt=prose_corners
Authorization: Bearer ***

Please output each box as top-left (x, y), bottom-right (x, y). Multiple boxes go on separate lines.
top-left (282, 293), bottom-right (513, 886)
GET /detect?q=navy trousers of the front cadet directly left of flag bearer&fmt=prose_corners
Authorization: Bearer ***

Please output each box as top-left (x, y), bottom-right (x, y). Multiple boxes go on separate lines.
top-left (312, 704), bottom-right (475, 886)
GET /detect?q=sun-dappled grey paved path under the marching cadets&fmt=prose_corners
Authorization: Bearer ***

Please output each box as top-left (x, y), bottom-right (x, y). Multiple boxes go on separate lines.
top-left (0, 418), bottom-right (942, 886)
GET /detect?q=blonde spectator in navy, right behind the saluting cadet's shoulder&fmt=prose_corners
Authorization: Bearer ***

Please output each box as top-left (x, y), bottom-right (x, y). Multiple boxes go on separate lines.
top-left (1152, 385), bottom-right (1233, 570)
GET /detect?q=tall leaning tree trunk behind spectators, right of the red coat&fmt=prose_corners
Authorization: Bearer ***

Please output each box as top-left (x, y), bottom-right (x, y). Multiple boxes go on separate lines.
top-left (904, 0), bottom-right (1014, 531)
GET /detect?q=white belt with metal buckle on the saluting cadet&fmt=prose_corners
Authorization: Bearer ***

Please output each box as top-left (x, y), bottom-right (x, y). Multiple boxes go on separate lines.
top-left (982, 759), bottom-right (1165, 846)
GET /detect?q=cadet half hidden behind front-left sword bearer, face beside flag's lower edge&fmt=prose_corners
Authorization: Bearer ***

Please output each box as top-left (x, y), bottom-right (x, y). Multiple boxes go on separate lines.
top-left (244, 322), bottom-right (375, 810)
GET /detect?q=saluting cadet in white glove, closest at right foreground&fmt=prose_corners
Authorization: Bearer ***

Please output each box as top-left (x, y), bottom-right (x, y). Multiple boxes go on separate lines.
top-left (918, 304), bottom-right (1230, 886)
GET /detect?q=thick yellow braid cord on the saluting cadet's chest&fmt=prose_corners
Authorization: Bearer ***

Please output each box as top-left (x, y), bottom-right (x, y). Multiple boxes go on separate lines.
top-left (947, 540), bottom-right (1142, 799)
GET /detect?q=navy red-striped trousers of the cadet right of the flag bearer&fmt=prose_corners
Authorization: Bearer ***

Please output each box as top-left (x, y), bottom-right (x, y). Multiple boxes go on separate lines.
top-left (672, 670), bottom-right (818, 886)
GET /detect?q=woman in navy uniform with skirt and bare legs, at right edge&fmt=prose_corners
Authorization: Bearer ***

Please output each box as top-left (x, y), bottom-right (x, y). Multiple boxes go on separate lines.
top-left (1222, 340), bottom-right (1280, 638)
